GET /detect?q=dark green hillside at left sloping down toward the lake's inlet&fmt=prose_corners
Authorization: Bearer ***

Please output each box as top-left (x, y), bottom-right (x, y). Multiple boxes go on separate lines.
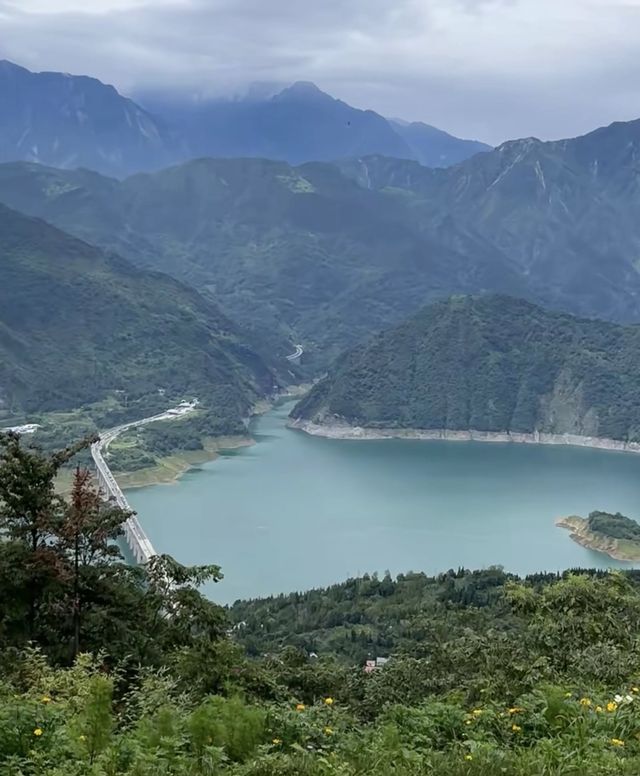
top-left (0, 200), bottom-right (277, 418)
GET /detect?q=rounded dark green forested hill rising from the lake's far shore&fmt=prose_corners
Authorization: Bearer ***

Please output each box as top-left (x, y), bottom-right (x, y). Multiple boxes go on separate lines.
top-left (292, 295), bottom-right (640, 442)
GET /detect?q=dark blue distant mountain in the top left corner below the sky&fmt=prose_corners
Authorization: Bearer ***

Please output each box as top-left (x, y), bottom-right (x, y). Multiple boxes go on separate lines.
top-left (0, 60), bottom-right (175, 176)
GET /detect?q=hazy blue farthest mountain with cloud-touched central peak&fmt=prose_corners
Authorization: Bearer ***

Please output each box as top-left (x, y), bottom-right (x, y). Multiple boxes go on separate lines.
top-left (143, 82), bottom-right (489, 167)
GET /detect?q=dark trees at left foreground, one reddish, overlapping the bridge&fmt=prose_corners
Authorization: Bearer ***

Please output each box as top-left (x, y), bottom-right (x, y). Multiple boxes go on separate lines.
top-left (0, 434), bottom-right (227, 668)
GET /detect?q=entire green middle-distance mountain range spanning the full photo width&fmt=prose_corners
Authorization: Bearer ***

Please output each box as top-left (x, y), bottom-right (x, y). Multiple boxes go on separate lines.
top-left (0, 111), bottom-right (640, 369)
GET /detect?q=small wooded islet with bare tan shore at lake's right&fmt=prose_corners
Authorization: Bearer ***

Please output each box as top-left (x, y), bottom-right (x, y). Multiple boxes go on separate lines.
top-left (556, 512), bottom-right (640, 562)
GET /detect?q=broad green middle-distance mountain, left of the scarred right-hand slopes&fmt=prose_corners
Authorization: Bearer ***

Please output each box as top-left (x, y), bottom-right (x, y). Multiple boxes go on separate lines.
top-left (0, 159), bottom-right (527, 367)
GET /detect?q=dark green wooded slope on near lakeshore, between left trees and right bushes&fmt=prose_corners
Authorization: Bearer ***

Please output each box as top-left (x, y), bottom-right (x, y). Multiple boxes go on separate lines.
top-left (230, 568), bottom-right (514, 664)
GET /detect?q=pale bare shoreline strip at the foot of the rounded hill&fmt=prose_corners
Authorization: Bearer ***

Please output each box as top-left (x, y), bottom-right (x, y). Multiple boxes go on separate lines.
top-left (287, 418), bottom-right (640, 453)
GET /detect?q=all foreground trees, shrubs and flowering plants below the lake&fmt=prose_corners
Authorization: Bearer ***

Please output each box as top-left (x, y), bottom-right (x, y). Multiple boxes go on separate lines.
top-left (0, 434), bottom-right (640, 776)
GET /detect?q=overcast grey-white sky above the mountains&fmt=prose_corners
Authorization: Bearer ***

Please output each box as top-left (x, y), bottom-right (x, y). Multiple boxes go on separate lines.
top-left (0, 0), bottom-right (640, 144)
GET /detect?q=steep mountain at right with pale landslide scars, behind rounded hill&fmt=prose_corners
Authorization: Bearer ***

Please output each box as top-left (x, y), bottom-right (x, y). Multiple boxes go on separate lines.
top-left (341, 121), bottom-right (640, 320)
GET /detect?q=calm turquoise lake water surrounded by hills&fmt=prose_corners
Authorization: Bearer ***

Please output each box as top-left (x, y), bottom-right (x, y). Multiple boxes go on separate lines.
top-left (127, 404), bottom-right (640, 603)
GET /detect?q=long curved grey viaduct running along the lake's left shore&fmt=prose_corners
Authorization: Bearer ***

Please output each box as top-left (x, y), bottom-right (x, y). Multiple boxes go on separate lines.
top-left (91, 400), bottom-right (198, 563)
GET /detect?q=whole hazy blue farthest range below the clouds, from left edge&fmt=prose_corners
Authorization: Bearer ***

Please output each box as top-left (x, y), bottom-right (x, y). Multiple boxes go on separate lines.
top-left (0, 60), bottom-right (489, 177)
